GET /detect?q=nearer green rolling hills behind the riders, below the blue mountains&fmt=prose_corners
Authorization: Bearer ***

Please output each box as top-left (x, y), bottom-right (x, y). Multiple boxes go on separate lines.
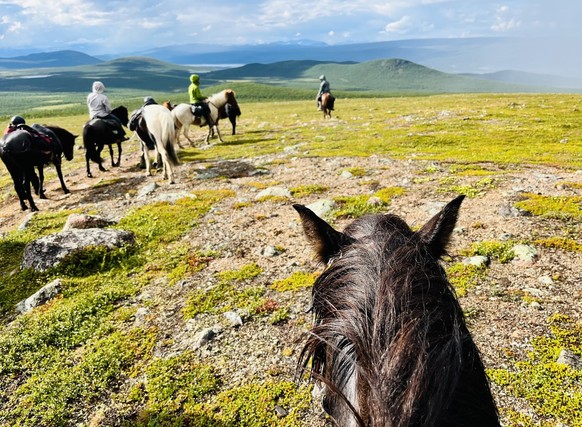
top-left (0, 57), bottom-right (580, 94)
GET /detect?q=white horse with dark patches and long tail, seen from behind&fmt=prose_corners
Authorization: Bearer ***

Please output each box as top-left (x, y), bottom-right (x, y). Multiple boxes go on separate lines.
top-left (132, 104), bottom-right (179, 184)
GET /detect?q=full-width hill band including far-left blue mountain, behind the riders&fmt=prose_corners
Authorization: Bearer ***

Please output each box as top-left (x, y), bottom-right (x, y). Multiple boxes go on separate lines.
top-left (0, 51), bottom-right (582, 94)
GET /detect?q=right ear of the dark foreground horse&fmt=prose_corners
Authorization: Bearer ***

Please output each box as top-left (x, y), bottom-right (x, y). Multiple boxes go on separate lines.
top-left (418, 195), bottom-right (465, 257)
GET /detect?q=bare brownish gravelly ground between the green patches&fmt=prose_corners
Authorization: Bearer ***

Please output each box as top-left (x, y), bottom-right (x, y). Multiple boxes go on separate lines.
top-left (0, 129), bottom-right (582, 426)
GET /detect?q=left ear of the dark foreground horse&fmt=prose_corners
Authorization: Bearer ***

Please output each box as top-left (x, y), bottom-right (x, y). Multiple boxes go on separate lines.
top-left (293, 204), bottom-right (353, 264)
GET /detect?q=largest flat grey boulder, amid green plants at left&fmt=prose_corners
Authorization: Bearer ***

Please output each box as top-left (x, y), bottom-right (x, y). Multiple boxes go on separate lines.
top-left (20, 228), bottom-right (135, 271)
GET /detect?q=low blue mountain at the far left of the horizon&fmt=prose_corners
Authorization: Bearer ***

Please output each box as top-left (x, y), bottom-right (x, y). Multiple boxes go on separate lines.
top-left (0, 50), bottom-right (103, 69)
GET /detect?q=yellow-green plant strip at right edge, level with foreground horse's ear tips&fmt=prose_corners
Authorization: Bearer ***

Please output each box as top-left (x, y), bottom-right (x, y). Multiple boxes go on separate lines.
top-left (515, 193), bottom-right (582, 219)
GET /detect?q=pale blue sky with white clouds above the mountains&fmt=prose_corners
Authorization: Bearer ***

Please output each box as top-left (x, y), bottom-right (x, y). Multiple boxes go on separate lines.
top-left (0, 0), bottom-right (582, 56)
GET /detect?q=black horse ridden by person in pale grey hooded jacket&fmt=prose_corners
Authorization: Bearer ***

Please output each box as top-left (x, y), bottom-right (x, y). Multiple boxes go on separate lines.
top-left (83, 105), bottom-right (129, 178)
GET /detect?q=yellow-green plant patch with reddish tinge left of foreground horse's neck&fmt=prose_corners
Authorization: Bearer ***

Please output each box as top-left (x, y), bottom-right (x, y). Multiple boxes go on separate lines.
top-left (182, 264), bottom-right (265, 318)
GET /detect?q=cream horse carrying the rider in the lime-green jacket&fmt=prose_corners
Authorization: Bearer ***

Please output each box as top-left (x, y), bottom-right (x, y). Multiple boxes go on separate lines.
top-left (172, 89), bottom-right (240, 146)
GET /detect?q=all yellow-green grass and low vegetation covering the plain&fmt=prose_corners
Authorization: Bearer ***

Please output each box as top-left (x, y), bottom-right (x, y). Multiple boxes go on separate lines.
top-left (0, 92), bottom-right (582, 427)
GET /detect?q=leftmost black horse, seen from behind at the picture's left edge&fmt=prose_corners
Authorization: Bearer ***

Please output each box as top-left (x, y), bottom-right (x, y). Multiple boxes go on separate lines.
top-left (0, 124), bottom-right (77, 212)
